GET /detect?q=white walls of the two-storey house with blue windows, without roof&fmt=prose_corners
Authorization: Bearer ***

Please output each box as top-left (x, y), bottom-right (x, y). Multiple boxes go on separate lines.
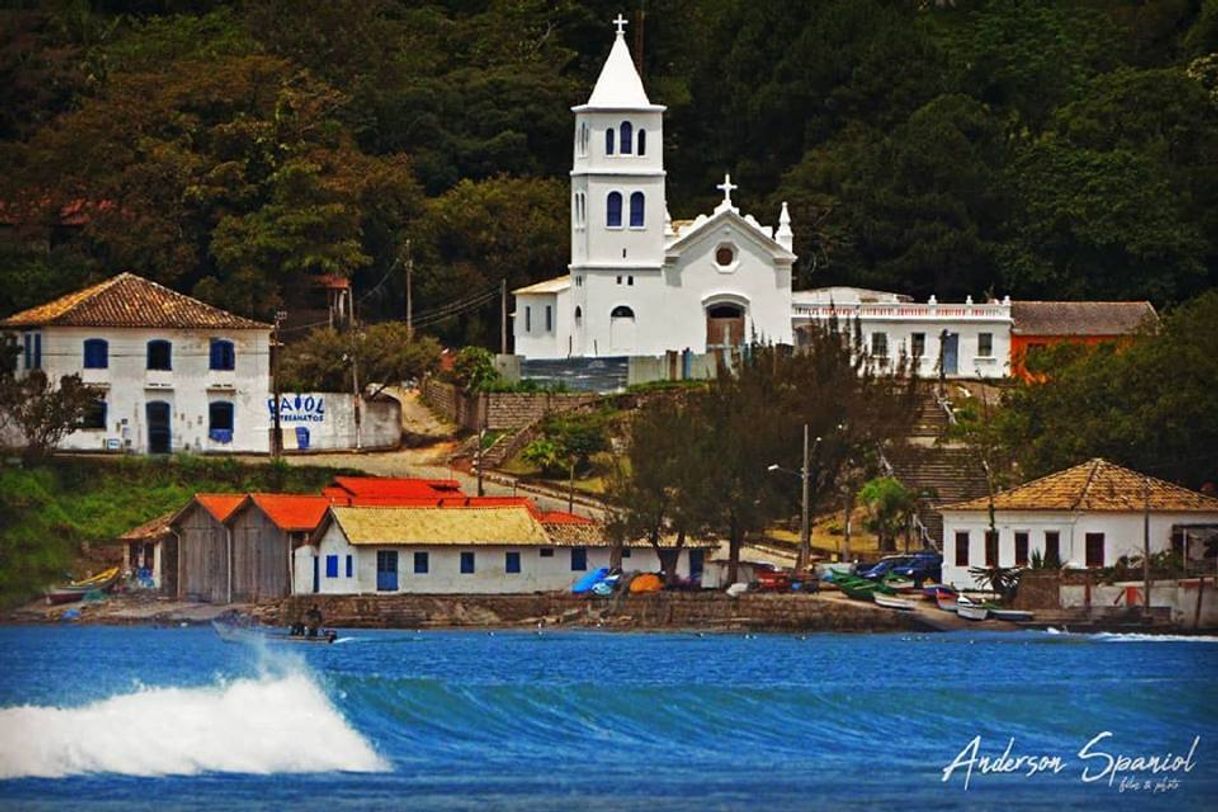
top-left (18, 327), bottom-right (270, 453)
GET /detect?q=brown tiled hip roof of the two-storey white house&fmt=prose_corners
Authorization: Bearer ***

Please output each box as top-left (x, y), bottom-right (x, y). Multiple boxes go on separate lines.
top-left (0, 273), bottom-right (270, 330)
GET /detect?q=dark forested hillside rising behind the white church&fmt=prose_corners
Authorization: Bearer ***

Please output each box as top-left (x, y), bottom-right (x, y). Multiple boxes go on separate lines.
top-left (0, 0), bottom-right (1218, 342)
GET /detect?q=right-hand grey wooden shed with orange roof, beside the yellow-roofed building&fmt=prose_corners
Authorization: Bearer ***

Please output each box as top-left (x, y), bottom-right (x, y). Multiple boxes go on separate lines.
top-left (227, 493), bottom-right (330, 603)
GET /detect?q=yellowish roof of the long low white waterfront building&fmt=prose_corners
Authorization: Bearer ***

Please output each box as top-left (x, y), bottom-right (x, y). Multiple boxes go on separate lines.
top-left (330, 506), bottom-right (551, 547)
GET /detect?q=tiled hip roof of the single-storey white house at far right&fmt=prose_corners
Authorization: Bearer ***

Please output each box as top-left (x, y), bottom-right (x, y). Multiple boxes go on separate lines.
top-left (939, 459), bottom-right (1218, 514)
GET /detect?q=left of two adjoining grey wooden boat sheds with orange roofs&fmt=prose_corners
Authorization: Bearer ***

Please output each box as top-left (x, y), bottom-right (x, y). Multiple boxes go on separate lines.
top-left (169, 493), bottom-right (245, 604)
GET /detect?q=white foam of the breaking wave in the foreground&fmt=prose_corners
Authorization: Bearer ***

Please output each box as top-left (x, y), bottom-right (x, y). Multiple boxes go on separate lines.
top-left (0, 672), bottom-right (389, 779)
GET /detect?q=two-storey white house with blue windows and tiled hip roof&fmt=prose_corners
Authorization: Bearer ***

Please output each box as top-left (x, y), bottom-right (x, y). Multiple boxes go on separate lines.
top-left (0, 274), bottom-right (270, 454)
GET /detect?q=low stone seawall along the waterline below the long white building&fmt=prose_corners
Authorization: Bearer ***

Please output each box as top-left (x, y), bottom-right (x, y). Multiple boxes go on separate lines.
top-left (258, 592), bottom-right (927, 632)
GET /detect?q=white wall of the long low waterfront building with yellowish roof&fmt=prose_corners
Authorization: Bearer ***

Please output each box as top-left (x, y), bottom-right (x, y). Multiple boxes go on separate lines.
top-left (294, 523), bottom-right (689, 594)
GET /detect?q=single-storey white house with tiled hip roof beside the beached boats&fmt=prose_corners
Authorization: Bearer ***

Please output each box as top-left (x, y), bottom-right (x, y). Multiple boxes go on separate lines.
top-left (940, 459), bottom-right (1218, 589)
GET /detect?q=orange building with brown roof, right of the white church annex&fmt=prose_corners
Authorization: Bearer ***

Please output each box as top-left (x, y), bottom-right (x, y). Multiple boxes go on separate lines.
top-left (1011, 302), bottom-right (1158, 380)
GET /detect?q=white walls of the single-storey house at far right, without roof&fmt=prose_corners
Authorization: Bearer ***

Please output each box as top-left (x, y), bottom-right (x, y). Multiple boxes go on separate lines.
top-left (943, 510), bottom-right (1218, 589)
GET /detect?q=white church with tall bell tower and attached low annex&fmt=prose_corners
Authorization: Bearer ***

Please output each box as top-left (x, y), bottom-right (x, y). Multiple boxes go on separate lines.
top-left (513, 15), bottom-right (1011, 377)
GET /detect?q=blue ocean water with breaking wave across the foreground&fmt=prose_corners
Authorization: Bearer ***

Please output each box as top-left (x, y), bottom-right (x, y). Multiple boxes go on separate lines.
top-left (0, 627), bottom-right (1218, 811)
